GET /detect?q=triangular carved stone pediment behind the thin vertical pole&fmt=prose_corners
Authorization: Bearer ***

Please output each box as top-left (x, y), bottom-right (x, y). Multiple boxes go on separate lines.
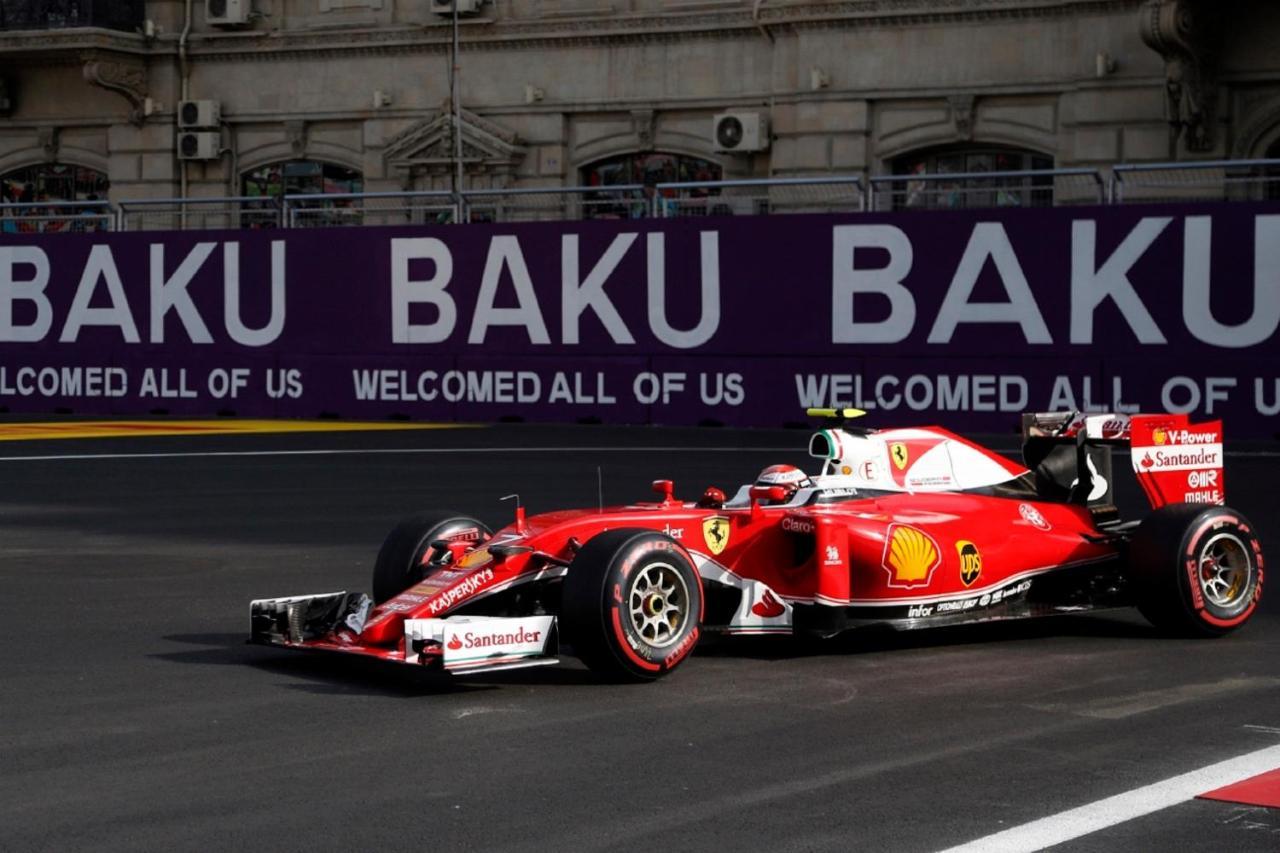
top-left (383, 101), bottom-right (526, 174)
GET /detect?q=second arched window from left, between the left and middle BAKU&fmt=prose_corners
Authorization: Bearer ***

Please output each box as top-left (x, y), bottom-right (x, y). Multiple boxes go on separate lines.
top-left (241, 160), bottom-right (365, 227)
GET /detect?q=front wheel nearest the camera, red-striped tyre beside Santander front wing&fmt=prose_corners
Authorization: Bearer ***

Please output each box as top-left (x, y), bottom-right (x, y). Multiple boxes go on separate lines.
top-left (561, 528), bottom-right (703, 681)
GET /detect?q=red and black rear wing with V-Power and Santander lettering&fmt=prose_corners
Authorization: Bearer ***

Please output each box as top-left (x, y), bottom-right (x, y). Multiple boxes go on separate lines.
top-left (1023, 412), bottom-right (1226, 508)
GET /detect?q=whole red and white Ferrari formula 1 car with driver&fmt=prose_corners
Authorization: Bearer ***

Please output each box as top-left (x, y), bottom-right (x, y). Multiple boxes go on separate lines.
top-left (251, 410), bottom-right (1263, 680)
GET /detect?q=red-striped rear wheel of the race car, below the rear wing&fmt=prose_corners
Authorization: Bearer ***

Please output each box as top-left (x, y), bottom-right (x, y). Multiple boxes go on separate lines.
top-left (1129, 503), bottom-right (1262, 637)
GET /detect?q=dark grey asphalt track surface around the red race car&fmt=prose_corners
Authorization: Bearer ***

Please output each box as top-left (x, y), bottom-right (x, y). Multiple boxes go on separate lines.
top-left (0, 425), bottom-right (1280, 852)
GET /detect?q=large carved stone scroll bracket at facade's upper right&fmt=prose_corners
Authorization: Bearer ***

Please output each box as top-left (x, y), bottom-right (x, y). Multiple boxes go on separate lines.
top-left (1139, 0), bottom-right (1222, 151)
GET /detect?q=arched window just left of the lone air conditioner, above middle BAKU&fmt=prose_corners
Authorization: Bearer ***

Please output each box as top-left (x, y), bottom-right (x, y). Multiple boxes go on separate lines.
top-left (582, 152), bottom-right (723, 219)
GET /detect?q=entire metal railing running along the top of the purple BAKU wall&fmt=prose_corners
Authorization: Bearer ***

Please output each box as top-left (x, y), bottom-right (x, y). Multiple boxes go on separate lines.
top-left (0, 159), bottom-right (1280, 236)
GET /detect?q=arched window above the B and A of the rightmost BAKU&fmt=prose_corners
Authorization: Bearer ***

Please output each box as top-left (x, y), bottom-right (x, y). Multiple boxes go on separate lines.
top-left (892, 145), bottom-right (1055, 209)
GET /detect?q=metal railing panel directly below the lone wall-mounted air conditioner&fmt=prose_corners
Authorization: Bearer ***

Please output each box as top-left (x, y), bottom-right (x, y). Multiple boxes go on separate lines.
top-left (650, 175), bottom-right (867, 218)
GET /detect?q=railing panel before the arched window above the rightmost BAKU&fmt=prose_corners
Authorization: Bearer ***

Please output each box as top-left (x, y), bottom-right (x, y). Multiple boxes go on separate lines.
top-left (870, 169), bottom-right (1107, 210)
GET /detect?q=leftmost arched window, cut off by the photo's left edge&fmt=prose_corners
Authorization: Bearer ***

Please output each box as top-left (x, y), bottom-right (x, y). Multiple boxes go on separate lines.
top-left (0, 163), bottom-right (111, 233)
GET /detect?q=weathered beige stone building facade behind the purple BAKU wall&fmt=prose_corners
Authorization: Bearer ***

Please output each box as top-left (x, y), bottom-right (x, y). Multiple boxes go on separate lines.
top-left (0, 0), bottom-right (1280, 207)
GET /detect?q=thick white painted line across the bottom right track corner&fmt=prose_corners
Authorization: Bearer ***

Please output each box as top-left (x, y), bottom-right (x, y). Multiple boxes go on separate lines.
top-left (942, 745), bottom-right (1280, 853)
